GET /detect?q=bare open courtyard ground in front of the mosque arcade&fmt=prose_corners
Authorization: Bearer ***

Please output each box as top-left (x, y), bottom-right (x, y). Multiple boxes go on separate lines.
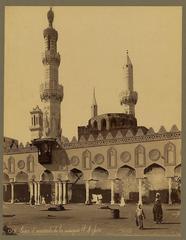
top-left (3, 204), bottom-right (181, 236)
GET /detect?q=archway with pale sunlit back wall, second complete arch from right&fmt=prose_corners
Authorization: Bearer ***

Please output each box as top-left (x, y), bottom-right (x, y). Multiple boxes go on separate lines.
top-left (115, 165), bottom-right (139, 202)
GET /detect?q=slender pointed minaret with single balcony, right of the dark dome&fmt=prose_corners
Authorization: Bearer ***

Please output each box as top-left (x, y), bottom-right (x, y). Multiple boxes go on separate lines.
top-left (120, 50), bottom-right (138, 116)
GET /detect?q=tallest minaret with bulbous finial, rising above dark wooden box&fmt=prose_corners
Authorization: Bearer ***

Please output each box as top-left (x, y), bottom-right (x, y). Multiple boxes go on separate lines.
top-left (40, 8), bottom-right (63, 138)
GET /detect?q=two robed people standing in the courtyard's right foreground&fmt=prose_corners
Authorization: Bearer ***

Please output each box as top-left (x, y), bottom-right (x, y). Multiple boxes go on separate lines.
top-left (135, 193), bottom-right (163, 229)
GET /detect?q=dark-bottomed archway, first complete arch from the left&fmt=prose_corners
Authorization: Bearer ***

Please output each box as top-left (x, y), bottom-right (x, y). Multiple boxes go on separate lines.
top-left (14, 171), bottom-right (30, 203)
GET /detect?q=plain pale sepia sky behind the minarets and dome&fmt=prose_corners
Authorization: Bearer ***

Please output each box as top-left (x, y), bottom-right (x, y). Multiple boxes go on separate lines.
top-left (4, 6), bottom-right (182, 143)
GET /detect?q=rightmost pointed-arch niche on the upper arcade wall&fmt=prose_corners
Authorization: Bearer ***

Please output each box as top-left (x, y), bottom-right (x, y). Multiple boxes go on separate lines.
top-left (164, 142), bottom-right (176, 165)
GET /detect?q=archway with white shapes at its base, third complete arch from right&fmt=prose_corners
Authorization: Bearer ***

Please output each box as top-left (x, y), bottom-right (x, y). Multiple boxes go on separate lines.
top-left (89, 167), bottom-right (111, 203)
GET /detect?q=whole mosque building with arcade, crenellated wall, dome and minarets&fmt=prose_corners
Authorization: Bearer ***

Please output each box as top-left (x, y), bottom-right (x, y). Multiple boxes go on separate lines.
top-left (3, 9), bottom-right (181, 204)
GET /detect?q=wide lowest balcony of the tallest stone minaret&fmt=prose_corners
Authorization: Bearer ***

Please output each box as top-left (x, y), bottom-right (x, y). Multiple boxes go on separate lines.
top-left (40, 83), bottom-right (63, 102)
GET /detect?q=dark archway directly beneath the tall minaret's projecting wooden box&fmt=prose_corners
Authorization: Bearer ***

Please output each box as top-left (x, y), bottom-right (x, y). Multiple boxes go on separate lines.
top-left (40, 170), bottom-right (55, 204)
